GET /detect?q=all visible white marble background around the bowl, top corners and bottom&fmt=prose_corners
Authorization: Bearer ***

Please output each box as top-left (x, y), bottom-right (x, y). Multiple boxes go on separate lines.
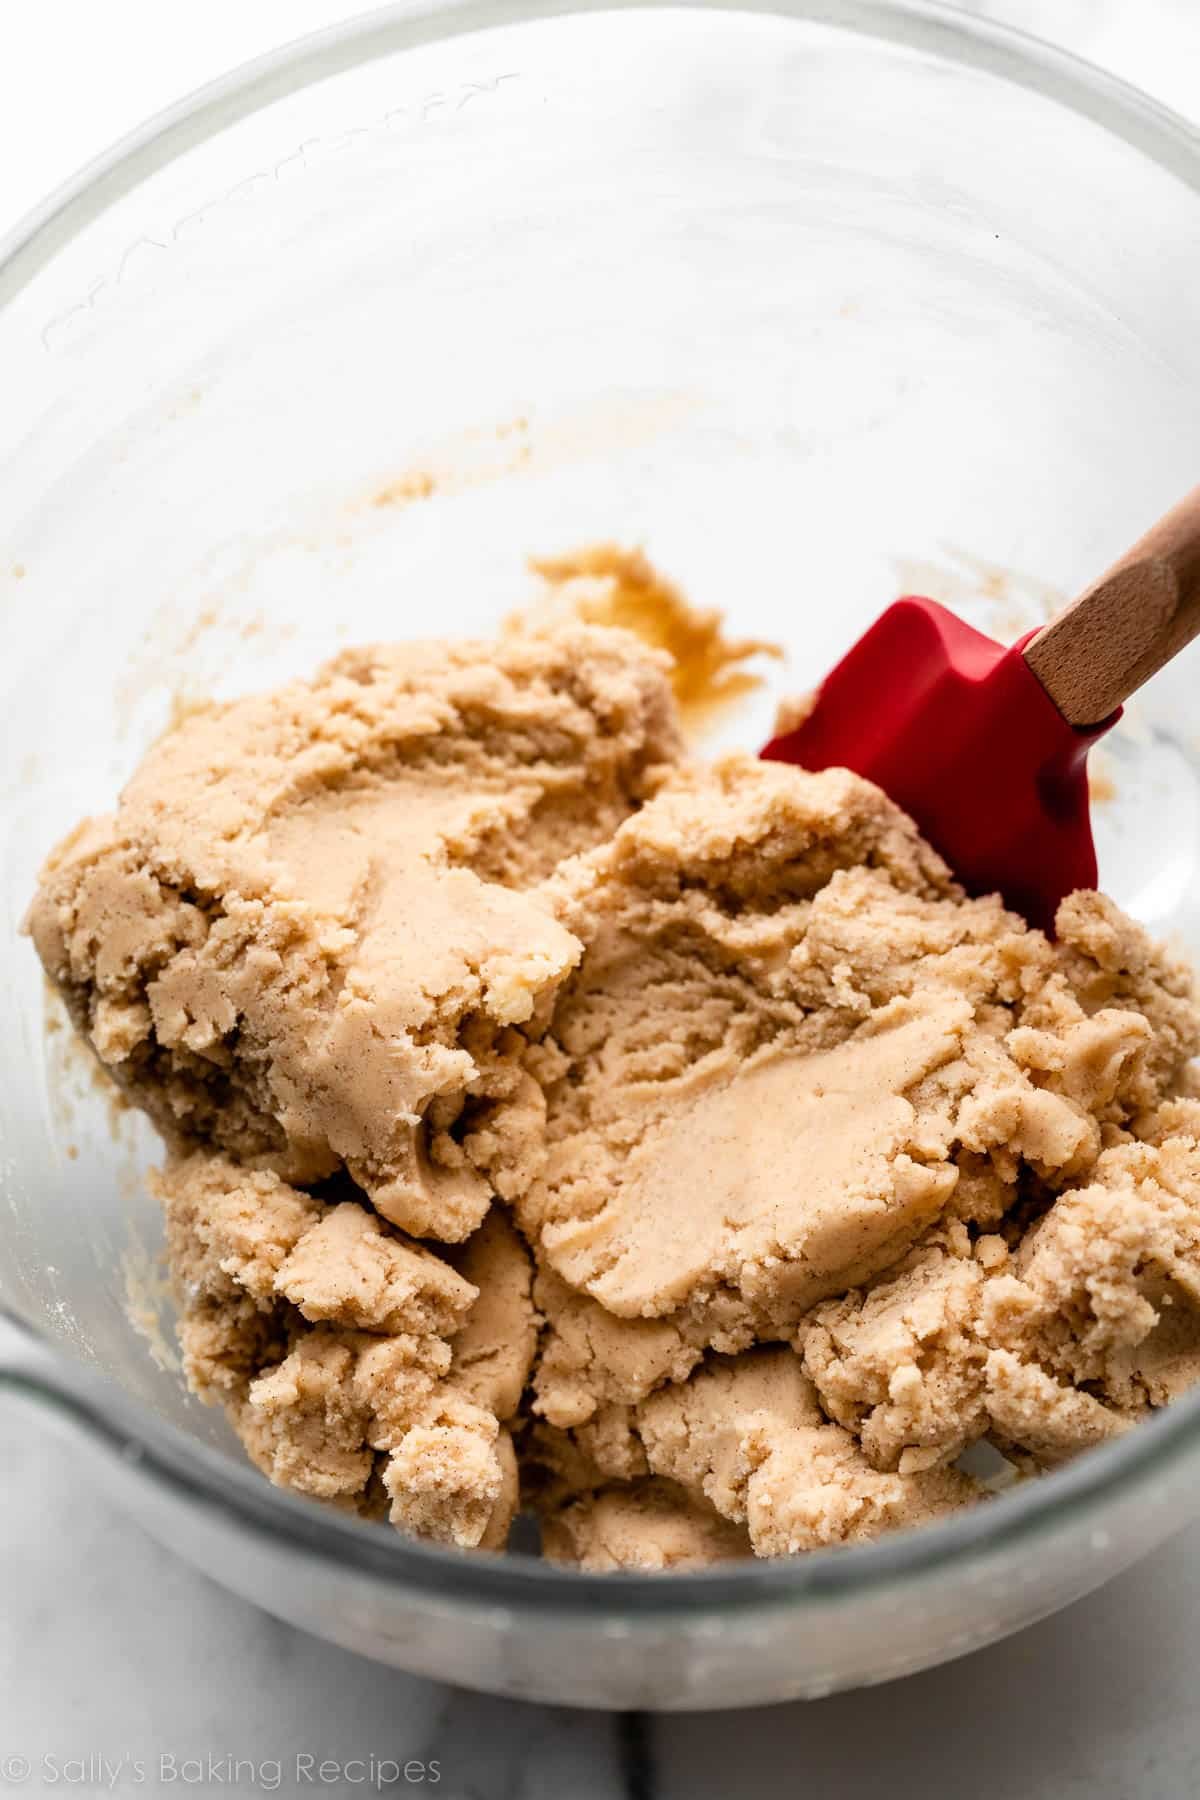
top-left (0, 0), bottom-right (1200, 1800)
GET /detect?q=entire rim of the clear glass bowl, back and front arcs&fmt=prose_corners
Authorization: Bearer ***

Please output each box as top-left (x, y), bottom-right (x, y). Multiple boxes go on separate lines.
top-left (0, 0), bottom-right (1200, 1625)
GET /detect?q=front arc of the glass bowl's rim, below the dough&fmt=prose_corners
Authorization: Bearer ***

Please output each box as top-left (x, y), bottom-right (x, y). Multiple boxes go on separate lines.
top-left (0, 1309), bottom-right (1200, 1624)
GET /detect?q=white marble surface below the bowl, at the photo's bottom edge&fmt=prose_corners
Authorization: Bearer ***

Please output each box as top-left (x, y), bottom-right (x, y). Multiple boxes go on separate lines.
top-left (0, 1368), bottom-right (1200, 1800)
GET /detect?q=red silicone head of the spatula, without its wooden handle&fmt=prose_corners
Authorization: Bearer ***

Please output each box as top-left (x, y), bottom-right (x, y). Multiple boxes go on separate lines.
top-left (763, 598), bottom-right (1117, 929)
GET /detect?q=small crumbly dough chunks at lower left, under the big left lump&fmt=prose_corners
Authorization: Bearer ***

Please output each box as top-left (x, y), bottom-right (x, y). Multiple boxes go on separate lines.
top-left (157, 1152), bottom-right (536, 1546)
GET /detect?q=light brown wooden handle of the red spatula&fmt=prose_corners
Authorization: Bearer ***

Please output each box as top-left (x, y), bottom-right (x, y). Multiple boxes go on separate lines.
top-left (1025, 488), bottom-right (1200, 725)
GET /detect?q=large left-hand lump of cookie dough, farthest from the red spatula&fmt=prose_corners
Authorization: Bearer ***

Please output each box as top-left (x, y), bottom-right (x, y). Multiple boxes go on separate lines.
top-left (29, 628), bottom-right (680, 1242)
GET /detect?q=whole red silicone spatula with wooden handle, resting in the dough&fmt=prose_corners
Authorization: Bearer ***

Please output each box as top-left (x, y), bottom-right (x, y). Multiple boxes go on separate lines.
top-left (763, 488), bottom-right (1200, 931)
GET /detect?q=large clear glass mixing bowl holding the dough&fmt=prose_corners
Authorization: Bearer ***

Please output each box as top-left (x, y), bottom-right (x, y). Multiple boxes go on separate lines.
top-left (0, 0), bottom-right (1200, 1708)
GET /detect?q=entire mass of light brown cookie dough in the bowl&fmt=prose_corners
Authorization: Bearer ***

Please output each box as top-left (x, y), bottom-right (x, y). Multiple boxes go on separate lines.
top-left (31, 601), bottom-right (1200, 1571)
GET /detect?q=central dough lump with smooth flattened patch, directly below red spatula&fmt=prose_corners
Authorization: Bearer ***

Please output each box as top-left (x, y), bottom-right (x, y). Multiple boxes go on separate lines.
top-left (518, 758), bottom-right (1178, 1352)
